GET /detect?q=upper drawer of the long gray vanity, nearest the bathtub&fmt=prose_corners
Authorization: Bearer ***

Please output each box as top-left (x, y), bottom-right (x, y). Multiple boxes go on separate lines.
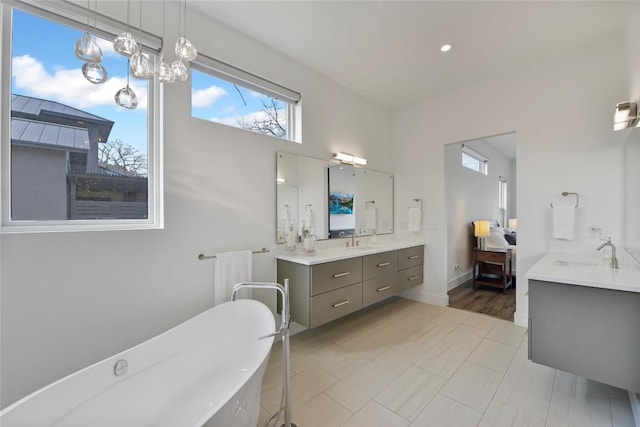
top-left (311, 257), bottom-right (362, 295)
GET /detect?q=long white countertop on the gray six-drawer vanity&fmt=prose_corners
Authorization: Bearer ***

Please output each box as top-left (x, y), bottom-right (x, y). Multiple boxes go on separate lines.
top-left (275, 240), bottom-right (424, 265)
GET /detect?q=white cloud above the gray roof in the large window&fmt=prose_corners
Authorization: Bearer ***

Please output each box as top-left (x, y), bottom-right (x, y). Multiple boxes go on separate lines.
top-left (12, 55), bottom-right (147, 110)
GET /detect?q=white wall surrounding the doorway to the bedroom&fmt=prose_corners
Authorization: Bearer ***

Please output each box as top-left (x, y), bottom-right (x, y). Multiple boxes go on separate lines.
top-left (393, 40), bottom-right (627, 324)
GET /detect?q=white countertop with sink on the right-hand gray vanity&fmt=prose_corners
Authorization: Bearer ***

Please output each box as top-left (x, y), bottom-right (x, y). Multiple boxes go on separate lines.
top-left (525, 249), bottom-right (640, 292)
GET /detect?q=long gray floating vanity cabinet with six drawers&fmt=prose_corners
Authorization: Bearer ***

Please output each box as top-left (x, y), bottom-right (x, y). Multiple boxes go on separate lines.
top-left (277, 246), bottom-right (424, 328)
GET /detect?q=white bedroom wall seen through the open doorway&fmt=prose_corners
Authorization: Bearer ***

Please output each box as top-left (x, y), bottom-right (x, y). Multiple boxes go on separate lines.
top-left (444, 138), bottom-right (515, 290)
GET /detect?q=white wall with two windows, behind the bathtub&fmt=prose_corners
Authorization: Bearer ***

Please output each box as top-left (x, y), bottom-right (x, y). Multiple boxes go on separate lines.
top-left (0, 2), bottom-right (392, 406)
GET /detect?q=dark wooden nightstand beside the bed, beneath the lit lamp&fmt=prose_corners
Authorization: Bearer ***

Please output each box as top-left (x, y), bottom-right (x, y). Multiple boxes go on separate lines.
top-left (473, 249), bottom-right (513, 292)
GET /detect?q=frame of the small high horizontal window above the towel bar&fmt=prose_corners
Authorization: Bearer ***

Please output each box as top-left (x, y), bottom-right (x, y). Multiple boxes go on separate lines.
top-left (190, 53), bottom-right (302, 143)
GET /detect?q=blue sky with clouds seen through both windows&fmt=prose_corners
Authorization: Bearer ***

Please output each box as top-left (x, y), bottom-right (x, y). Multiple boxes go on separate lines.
top-left (11, 9), bottom-right (284, 154)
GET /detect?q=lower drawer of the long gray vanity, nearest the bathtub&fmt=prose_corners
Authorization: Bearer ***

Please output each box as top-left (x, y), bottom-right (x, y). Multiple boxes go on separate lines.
top-left (310, 283), bottom-right (362, 328)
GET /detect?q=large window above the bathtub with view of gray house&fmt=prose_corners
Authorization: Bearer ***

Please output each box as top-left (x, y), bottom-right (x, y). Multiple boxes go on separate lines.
top-left (2, 2), bottom-right (162, 232)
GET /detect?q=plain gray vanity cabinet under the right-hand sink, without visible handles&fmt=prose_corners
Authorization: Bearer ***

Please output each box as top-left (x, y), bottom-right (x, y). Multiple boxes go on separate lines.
top-left (529, 279), bottom-right (640, 392)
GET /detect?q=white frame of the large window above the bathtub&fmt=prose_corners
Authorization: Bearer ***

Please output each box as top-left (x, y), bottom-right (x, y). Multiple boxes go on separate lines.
top-left (0, 0), bottom-right (164, 234)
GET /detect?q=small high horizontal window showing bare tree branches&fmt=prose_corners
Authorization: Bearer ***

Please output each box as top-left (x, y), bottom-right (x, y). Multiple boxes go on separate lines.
top-left (191, 55), bottom-right (300, 142)
